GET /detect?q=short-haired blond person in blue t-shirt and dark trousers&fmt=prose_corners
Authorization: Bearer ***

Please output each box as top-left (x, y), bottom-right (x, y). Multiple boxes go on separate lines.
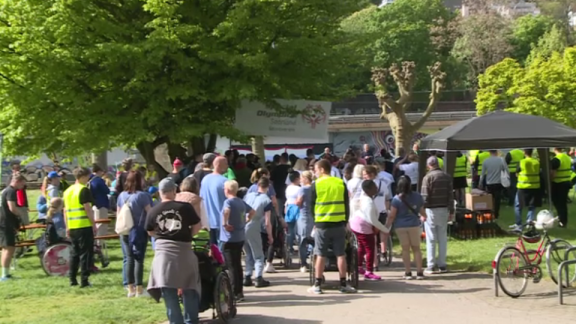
top-left (220, 180), bottom-right (254, 301)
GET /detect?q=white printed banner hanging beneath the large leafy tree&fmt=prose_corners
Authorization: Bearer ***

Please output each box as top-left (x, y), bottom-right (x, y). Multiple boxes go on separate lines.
top-left (235, 99), bottom-right (332, 142)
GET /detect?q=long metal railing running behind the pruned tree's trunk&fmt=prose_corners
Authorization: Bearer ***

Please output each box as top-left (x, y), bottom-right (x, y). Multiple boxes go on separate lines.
top-left (330, 111), bottom-right (476, 125)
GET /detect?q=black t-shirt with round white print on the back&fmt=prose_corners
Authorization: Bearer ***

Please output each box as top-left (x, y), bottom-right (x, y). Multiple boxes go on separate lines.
top-left (146, 201), bottom-right (200, 242)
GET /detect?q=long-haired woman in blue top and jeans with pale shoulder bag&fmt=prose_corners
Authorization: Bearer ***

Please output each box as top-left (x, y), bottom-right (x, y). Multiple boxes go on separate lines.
top-left (117, 171), bottom-right (152, 297)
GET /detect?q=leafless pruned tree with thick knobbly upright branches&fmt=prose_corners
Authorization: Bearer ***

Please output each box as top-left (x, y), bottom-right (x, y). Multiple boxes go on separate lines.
top-left (372, 62), bottom-right (446, 151)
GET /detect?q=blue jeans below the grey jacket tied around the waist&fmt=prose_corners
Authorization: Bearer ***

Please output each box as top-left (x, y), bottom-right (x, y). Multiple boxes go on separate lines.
top-left (162, 288), bottom-right (200, 324)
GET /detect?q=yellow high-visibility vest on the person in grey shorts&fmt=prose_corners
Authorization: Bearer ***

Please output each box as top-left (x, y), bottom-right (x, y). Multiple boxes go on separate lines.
top-left (314, 176), bottom-right (346, 223)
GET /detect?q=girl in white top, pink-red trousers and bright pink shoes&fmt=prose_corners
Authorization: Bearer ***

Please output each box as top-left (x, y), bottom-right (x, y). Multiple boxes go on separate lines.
top-left (350, 180), bottom-right (390, 280)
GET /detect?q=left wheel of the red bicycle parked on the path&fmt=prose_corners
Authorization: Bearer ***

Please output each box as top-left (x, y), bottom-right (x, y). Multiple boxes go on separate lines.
top-left (495, 246), bottom-right (529, 298)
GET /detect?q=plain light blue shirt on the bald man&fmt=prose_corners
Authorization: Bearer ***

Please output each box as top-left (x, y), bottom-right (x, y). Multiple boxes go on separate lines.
top-left (200, 173), bottom-right (228, 229)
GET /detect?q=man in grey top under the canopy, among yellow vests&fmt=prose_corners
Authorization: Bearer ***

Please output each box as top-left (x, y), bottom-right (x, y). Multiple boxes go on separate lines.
top-left (479, 150), bottom-right (508, 219)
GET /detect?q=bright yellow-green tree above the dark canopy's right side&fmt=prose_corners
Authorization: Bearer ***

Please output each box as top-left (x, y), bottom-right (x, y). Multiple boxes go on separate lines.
top-left (476, 47), bottom-right (576, 127)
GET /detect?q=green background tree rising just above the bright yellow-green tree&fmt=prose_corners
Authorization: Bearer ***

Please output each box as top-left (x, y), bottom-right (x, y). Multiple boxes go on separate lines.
top-left (511, 15), bottom-right (555, 62)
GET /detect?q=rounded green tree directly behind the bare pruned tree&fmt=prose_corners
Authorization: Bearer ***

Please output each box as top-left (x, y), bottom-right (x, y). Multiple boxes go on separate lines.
top-left (343, 0), bottom-right (455, 91)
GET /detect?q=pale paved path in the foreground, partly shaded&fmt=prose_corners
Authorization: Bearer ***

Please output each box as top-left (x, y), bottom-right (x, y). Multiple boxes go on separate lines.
top-left (174, 261), bottom-right (576, 324)
